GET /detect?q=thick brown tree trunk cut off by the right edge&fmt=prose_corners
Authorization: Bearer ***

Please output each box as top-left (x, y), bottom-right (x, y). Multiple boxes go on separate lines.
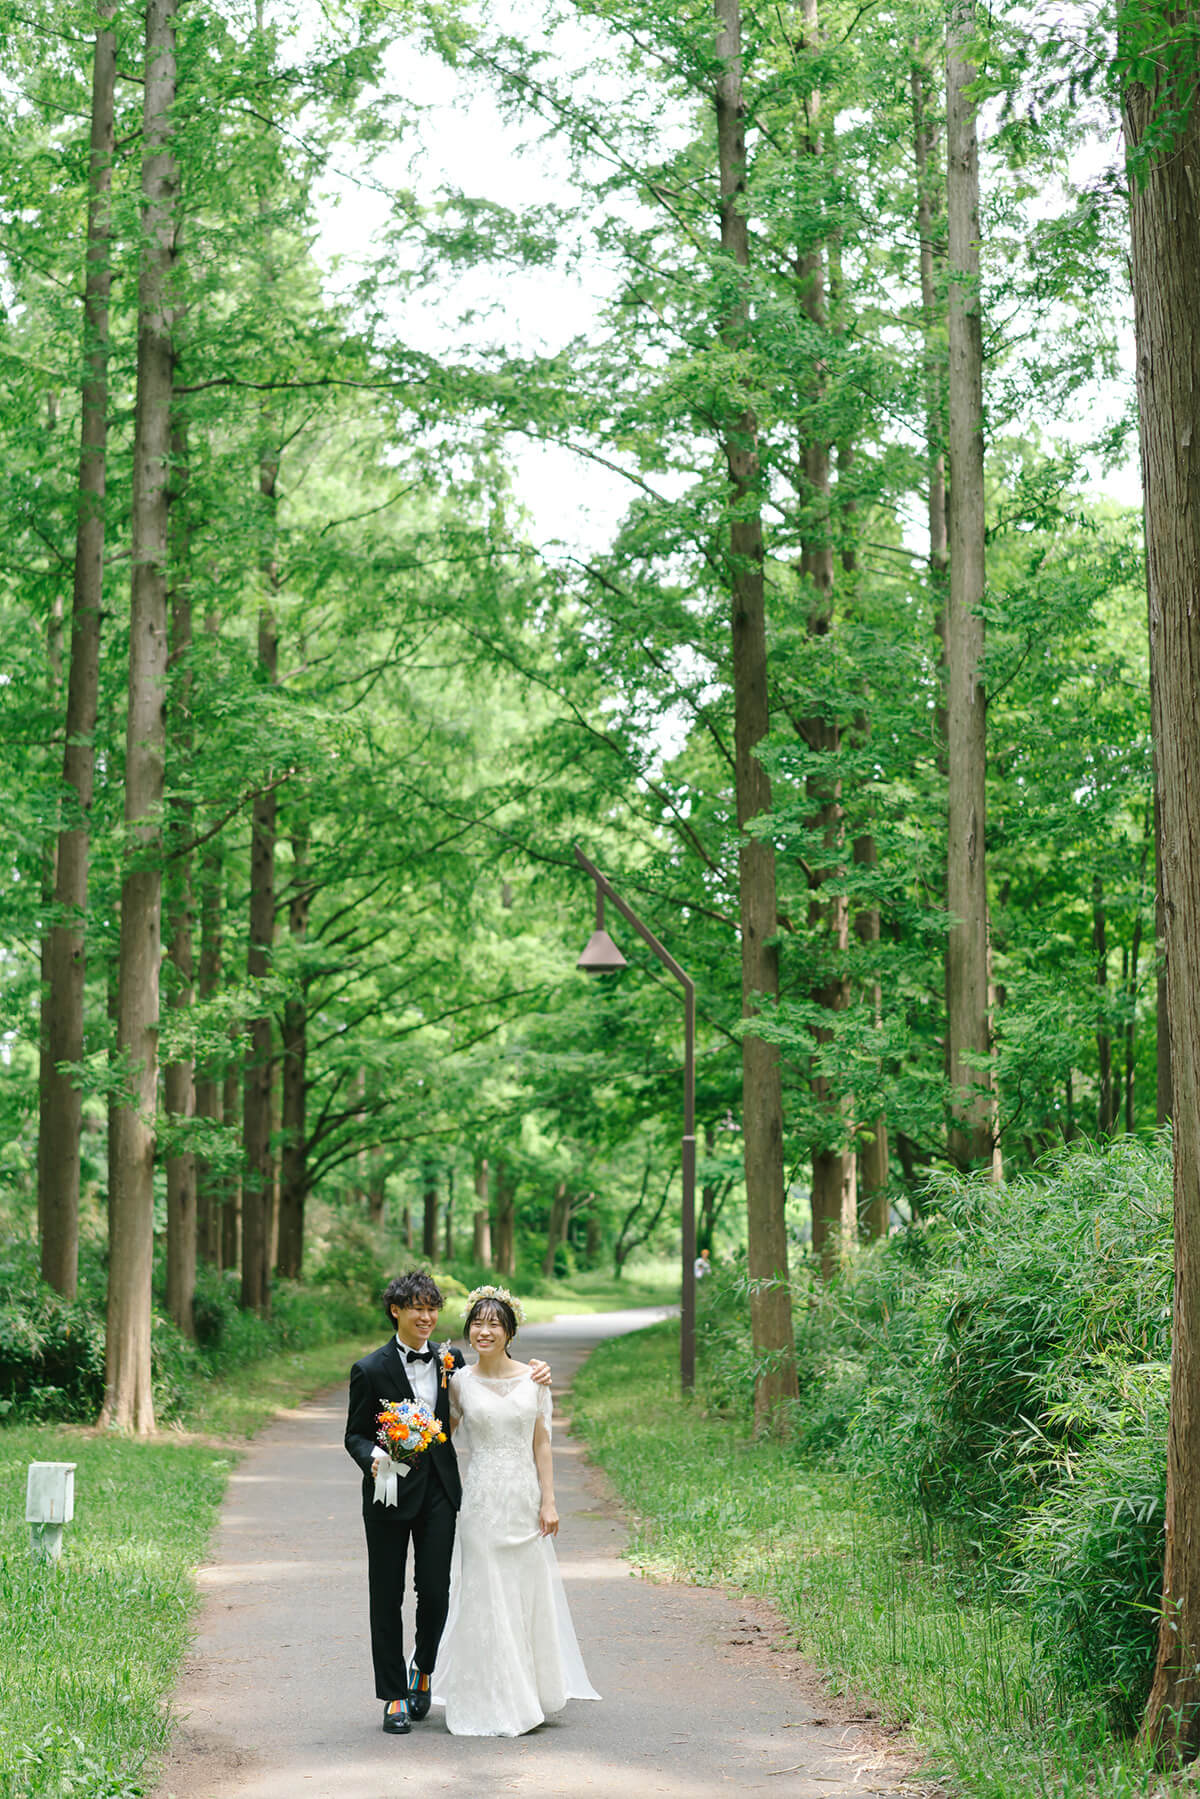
top-left (1117, 31), bottom-right (1200, 1761)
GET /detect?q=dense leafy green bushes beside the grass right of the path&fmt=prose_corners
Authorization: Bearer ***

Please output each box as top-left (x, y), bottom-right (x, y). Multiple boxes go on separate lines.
top-left (680, 1139), bottom-right (1171, 1731)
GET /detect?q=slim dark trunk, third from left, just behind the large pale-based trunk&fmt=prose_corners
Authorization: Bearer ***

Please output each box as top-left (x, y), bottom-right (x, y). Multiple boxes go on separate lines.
top-left (164, 413), bottom-right (196, 1337)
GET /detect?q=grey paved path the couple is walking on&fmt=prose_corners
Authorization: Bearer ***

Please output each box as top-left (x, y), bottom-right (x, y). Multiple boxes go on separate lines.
top-left (157, 1311), bottom-right (903, 1799)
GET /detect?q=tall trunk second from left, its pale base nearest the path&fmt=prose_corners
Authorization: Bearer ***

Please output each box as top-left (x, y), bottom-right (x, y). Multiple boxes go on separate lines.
top-left (101, 0), bottom-right (178, 1432)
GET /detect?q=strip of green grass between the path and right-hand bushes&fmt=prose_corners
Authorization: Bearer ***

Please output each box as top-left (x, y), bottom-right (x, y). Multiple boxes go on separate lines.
top-left (572, 1324), bottom-right (1166, 1799)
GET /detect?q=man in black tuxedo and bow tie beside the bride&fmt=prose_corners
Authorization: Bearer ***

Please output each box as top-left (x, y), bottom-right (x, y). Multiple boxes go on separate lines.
top-left (345, 1268), bottom-right (551, 1736)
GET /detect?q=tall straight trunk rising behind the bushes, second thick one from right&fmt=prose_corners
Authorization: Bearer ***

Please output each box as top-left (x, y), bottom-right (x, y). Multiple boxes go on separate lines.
top-left (946, 0), bottom-right (995, 1168)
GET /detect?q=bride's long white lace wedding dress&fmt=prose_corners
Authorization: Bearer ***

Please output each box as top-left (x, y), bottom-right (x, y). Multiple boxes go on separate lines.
top-left (434, 1367), bottom-right (599, 1736)
